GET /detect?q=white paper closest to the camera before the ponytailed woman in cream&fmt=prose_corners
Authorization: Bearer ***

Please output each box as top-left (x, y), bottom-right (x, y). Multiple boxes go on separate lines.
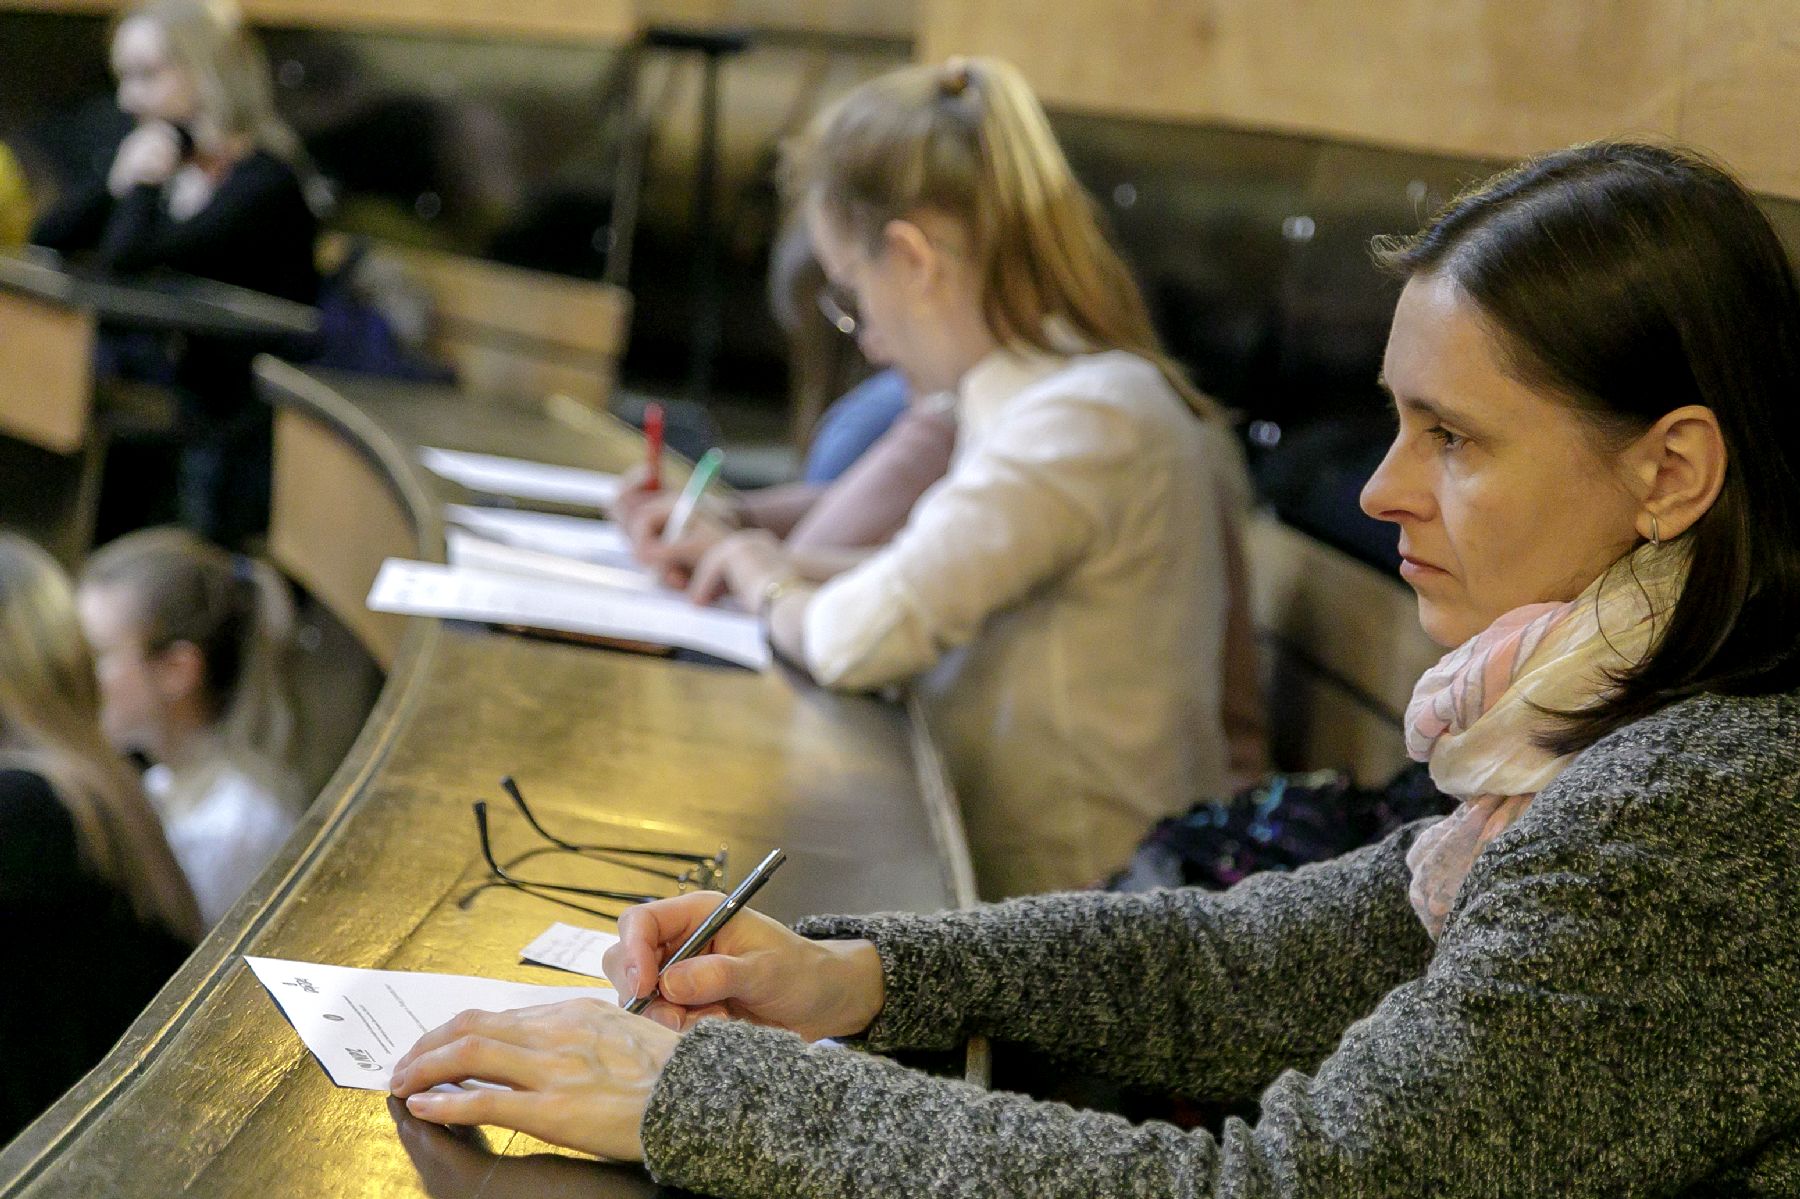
top-left (369, 558), bottom-right (772, 670)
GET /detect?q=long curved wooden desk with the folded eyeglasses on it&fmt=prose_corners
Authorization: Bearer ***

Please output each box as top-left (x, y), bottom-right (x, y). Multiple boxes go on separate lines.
top-left (0, 358), bottom-right (970, 1199)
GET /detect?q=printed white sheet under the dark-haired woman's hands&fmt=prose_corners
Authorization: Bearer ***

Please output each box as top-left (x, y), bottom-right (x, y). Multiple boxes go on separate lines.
top-left (245, 954), bottom-right (619, 1091)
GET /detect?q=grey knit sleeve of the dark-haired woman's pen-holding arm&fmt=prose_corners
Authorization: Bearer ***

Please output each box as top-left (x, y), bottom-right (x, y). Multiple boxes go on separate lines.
top-left (799, 820), bottom-right (1431, 1096)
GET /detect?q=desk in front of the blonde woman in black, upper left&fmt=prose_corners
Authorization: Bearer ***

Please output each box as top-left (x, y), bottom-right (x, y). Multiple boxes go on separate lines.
top-left (0, 248), bottom-right (319, 562)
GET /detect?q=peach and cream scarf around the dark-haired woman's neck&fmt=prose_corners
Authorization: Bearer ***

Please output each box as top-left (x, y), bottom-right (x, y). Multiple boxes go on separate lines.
top-left (1406, 544), bottom-right (1688, 940)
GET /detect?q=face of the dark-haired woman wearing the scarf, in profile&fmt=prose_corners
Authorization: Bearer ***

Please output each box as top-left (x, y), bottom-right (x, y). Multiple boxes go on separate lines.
top-left (1363, 275), bottom-right (1643, 646)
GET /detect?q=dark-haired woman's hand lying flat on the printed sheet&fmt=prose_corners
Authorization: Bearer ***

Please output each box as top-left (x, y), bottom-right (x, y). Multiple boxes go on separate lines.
top-left (389, 999), bottom-right (680, 1161)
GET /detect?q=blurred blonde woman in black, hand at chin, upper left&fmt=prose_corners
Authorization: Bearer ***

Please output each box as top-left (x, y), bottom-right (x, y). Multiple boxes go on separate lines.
top-left (32, 0), bottom-right (319, 542)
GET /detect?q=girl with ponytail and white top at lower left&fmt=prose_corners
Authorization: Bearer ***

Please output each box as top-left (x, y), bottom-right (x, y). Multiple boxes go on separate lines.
top-left (79, 527), bottom-right (301, 925)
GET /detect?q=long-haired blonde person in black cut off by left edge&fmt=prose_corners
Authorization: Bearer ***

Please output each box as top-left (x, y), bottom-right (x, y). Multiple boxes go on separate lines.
top-left (0, 533), bottom-right (202, 1143)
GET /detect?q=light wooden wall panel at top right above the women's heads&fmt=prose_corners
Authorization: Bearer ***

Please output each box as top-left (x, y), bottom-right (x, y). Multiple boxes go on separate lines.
top-left (918, 0), bottom-right (1800, 196)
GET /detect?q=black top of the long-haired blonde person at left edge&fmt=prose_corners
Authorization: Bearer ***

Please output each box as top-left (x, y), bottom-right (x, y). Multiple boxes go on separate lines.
top-left (0, 771), bottom-right (187, 1145)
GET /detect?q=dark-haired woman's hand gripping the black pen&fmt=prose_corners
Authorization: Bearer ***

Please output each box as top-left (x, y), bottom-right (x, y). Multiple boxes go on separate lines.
top-left (605, 891), bottom-right (887, 1041)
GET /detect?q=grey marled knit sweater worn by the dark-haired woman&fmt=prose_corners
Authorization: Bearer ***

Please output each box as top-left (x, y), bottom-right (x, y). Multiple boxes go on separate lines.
top-left (643, 695), bottom-right (1800, 1199)
